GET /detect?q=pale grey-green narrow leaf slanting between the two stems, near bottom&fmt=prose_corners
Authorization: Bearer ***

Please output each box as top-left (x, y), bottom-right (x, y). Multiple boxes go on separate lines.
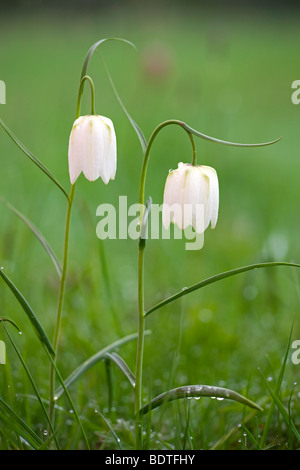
top-left (55, 331), bottom-right (149, 399)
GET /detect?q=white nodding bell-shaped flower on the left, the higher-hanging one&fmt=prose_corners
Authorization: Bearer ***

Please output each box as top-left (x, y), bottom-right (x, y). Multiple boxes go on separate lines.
top-left (68, 114), bottom-right (117, 184)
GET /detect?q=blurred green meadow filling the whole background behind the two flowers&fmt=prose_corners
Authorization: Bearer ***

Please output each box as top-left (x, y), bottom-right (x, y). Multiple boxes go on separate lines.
top-left (0, 9), bottom-right (300, 450)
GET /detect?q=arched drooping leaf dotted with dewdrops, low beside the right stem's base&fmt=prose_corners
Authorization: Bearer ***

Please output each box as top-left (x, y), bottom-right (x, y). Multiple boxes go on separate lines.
top-left (139, 385), bottom-right (262, 414)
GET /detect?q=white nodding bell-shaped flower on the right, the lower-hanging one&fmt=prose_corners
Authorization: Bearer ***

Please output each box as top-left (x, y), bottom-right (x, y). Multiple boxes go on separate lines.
top-left (162, 163), bottom-right (219, 233)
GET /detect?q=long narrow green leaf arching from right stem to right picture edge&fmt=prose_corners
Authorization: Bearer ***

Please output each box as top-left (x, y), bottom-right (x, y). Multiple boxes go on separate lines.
top-left (145, 262), bottom-right (300, 316)
